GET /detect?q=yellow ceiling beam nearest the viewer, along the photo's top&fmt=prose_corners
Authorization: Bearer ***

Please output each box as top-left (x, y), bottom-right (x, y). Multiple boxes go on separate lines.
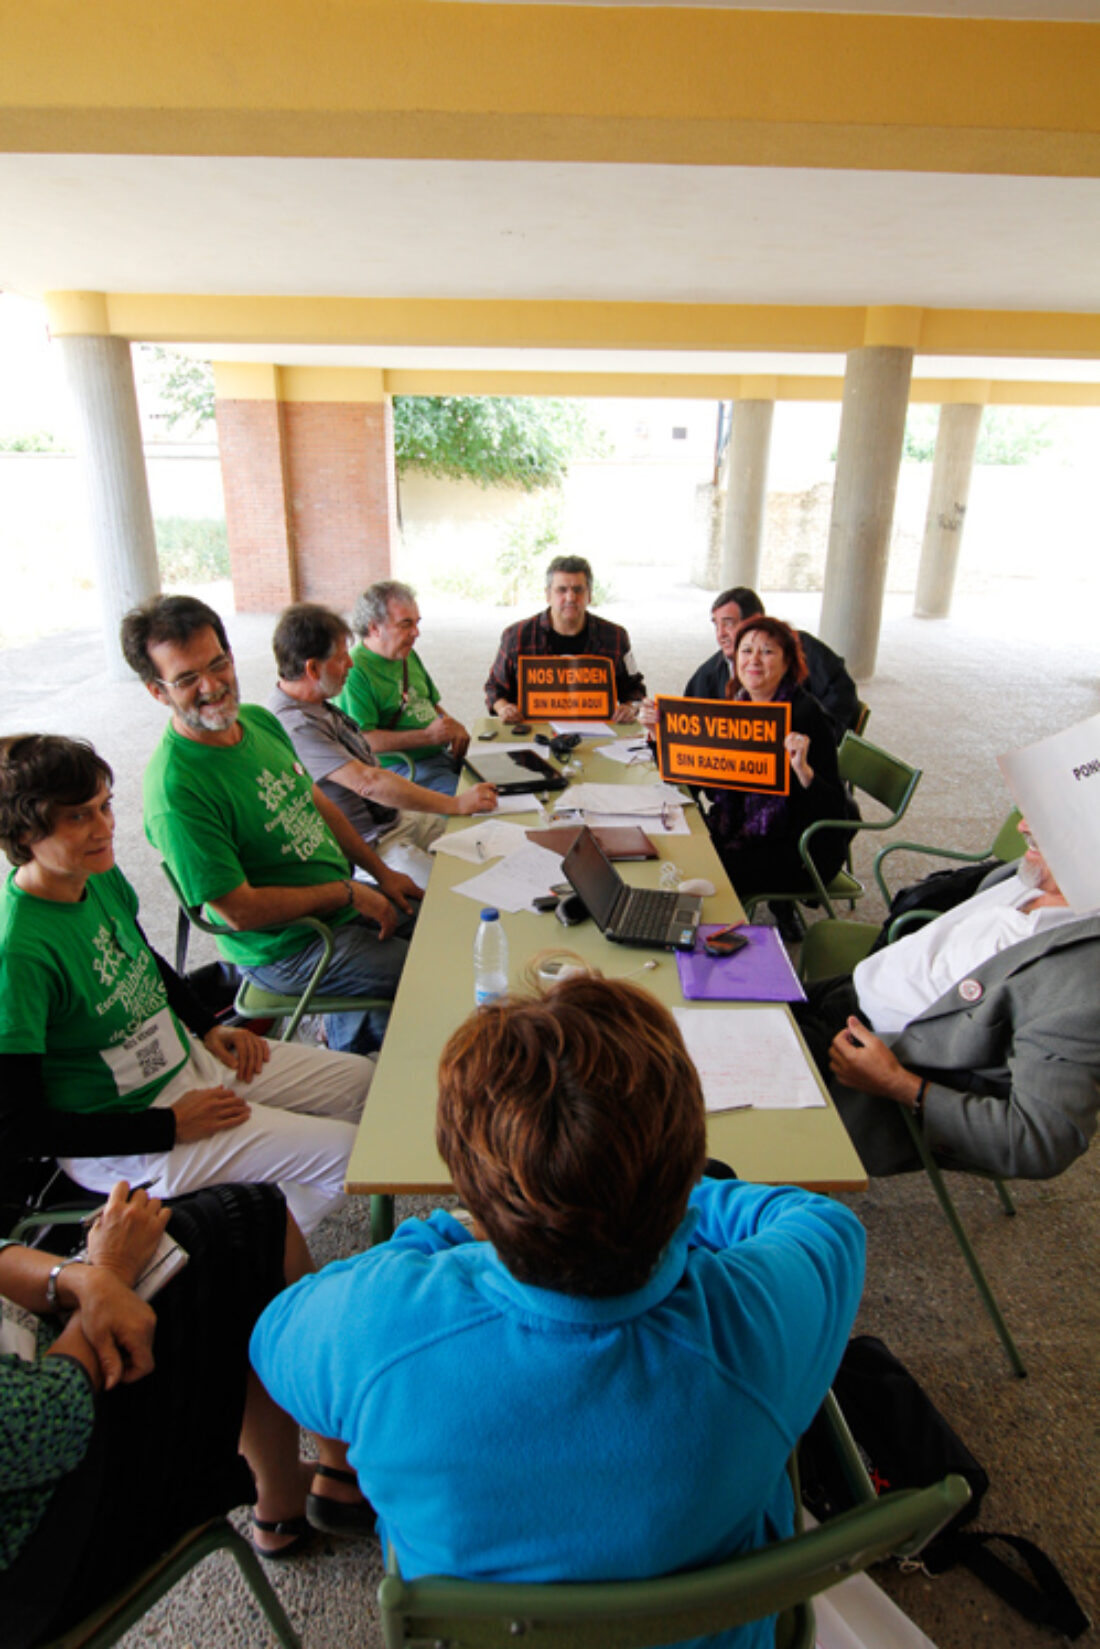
top-left (0, 0), bottom-right (1100, 176)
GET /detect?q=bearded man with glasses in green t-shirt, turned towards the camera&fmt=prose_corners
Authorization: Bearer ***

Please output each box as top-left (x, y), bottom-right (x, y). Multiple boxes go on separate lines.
top-left (122, 595), bottom-right (421, 1054)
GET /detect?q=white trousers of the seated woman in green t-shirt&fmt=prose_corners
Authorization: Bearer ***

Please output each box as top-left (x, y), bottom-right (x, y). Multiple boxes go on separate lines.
top-left (61, 1037), bottom-right (374, 1235)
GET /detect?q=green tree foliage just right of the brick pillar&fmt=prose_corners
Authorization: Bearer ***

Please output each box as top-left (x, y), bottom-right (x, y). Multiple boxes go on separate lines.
top-left (394, 396), bottom-right (599, 493)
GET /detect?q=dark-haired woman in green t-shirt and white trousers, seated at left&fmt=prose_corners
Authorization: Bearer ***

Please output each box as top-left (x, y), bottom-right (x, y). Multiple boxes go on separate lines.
top-left (0, 734), bottom-right (373, 1232)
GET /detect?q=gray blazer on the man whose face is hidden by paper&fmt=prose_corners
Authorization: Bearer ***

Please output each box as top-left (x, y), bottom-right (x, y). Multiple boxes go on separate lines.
top-left (833, 897), bottom-right (1100, 1179)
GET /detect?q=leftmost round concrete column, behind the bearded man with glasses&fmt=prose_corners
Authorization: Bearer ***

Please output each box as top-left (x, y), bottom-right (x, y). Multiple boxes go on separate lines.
top-left (52, 303), bottom-right (160, 679)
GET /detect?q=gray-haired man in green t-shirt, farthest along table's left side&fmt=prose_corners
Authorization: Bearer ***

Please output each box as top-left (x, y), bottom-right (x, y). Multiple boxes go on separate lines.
top-left (336, 579), bottom-right (470, 796)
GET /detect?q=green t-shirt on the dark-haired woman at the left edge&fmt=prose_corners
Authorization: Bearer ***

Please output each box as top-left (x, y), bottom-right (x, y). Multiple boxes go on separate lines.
top-left (0, 869), bottom-right (190, 1111)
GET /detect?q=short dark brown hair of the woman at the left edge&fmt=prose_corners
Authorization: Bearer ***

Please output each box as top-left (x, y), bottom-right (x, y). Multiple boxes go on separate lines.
top-left (0, 732), bottom-right (114, 864)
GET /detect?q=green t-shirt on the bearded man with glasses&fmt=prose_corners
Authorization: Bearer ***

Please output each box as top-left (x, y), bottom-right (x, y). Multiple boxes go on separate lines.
top-left (145, 704), bottom-right (355, 968)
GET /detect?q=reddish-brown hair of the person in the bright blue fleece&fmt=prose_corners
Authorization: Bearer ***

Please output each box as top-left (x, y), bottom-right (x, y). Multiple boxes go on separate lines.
top-left (435, 975), bottom-right (706, 1296)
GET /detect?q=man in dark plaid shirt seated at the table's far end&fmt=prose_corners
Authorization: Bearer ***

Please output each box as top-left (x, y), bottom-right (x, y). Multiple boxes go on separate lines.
top-left (485, 556), bottom-right (645, 722)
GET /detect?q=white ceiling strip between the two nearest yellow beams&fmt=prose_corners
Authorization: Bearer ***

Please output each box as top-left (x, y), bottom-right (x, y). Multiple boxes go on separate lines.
top-left (0, 155), bottom-right (1100, 312)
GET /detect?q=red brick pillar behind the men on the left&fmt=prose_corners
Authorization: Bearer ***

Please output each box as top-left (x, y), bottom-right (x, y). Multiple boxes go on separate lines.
top-left (218, 401), bottom-right (397, 613)
